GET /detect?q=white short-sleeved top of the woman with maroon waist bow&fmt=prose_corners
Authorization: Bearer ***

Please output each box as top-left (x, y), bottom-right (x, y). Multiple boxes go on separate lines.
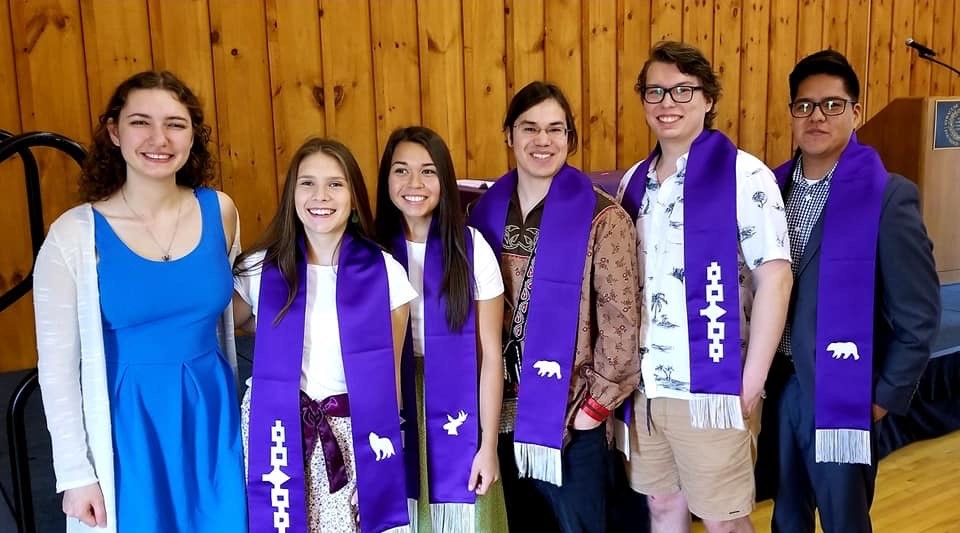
top-left (233, 252), bottom-right (417, 400)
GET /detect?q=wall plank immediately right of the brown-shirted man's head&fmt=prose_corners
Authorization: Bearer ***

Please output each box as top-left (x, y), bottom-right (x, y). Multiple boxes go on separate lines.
top-left (580, 1), bottom-right (617, 171)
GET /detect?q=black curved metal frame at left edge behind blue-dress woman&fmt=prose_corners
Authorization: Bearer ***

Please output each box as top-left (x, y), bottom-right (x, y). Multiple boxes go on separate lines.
top-left (0, 130), bottom-right (87, 533)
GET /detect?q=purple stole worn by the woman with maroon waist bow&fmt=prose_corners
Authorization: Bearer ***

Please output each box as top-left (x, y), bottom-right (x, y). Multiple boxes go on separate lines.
top-left (247, 237), bottom-right (409, 533)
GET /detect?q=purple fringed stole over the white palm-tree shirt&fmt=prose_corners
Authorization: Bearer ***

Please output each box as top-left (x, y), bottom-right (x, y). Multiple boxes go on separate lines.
top-left (621, 130), bottom-right (744, 429)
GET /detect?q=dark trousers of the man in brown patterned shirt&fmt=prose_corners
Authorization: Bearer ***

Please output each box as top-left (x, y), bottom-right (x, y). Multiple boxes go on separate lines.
top-left (497, 424), bottom-right (610, 533)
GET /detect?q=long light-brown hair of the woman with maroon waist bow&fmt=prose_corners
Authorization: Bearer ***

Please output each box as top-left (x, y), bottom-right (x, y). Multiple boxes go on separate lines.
top-left (233, 137), bottom-right (373, 323)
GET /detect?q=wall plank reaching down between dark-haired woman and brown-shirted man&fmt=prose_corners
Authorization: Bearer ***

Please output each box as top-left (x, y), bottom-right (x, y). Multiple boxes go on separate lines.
top-left (459, 0), bottom-right (507, 178)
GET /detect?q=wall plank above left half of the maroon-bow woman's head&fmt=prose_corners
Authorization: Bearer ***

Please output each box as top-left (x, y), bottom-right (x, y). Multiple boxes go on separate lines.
top-left (266, 0), bottom-right (326, 181)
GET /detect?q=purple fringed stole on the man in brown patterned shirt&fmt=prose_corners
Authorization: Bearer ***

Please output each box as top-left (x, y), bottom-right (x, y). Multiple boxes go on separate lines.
top-left (470, 165), bottom-right (597, 485)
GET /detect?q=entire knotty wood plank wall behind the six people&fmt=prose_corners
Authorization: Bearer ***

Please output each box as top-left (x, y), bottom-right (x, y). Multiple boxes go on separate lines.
top-left (0, 0), bottom-right (960, 370)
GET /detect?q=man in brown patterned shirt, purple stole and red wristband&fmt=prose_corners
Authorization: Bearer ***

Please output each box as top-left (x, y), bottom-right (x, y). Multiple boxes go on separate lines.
top-left (470, 81), bottom-right (640, 533)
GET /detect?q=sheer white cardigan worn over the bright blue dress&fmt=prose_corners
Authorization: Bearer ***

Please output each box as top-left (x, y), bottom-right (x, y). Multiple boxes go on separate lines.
top-left (33, 204), bottom-right (240, 533)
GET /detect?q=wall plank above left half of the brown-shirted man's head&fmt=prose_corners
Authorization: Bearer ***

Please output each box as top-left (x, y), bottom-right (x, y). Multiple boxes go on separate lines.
top-left (506, 0), bottom-right (546, 93)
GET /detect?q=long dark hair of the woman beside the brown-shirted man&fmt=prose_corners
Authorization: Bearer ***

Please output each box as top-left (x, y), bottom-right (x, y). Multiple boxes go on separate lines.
top-left (376, 126), bottom-right (473, 330)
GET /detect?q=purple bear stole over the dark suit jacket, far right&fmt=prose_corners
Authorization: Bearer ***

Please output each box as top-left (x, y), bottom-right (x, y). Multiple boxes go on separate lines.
top-left (774, 134), bottom-right (888, 464)
